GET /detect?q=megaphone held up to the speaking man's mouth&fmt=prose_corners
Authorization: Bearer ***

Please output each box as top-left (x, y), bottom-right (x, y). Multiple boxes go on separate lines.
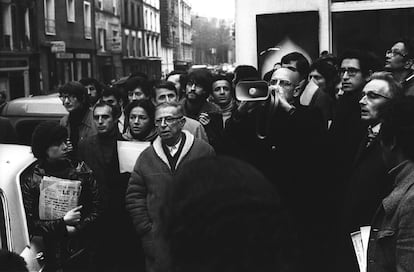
top-left (235, 80), bottom-right (269, 101)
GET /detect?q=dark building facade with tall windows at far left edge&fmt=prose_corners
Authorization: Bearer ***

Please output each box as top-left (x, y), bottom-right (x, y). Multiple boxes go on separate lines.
top-left (0, 0), bottom-right (39, 99)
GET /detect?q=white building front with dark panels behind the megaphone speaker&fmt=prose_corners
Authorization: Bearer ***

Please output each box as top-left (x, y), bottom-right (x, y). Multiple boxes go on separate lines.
top-left (235, 0), bottom-right (414, 77)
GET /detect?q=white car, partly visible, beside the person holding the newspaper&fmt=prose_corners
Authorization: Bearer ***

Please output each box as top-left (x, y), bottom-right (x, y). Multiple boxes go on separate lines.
top-left (0, 144), bottom-right (44, 271)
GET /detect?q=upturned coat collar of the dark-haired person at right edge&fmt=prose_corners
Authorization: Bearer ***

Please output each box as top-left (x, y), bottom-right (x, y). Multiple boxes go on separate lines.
top-left (382, 160), bottom-right (414, 214)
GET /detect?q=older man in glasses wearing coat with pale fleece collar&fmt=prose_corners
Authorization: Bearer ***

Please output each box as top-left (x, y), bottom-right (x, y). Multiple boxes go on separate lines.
top-left (126, 102), bottom-right (214, 272)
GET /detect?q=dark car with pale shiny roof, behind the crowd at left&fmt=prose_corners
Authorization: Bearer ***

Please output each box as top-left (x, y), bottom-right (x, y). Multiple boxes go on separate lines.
top-left (1, 93), bottom-right (68, 145)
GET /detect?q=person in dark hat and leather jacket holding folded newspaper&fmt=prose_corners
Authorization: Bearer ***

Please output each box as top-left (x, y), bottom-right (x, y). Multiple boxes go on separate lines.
top-left (22, 122), bottom-right (100, 271)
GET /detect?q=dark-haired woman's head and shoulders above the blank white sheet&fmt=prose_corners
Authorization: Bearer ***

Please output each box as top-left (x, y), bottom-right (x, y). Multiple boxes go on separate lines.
top-left (122, 100), bottom-right (157, 142)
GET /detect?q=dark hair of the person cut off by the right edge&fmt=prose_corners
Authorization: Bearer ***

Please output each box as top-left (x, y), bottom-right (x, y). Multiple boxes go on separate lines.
top-left (380, 96), bottom-right (414, 161)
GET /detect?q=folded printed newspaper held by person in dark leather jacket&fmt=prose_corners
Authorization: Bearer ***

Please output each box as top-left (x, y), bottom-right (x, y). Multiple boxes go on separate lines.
top-left (39, 176), bottom-right (82, 220)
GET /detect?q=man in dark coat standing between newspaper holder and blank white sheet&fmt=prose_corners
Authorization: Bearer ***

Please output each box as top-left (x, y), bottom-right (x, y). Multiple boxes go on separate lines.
top-left (77, 101), bottom-right (144, 271)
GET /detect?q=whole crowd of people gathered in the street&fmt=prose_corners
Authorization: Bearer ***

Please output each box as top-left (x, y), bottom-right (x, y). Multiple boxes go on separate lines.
top-left (0, 40), bottom-right (414, 272)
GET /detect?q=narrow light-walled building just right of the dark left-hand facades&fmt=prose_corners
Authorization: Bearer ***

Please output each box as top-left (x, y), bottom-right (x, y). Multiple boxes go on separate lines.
top-left (95, 0), bottom-right (124, 84)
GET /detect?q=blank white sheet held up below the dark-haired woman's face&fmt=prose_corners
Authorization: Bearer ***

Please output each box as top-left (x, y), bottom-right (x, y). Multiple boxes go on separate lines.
top-left (117, 141), bottom-right (151, 173)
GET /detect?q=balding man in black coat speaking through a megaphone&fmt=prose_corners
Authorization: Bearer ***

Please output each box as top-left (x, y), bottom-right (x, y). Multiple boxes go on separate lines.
top-left (225, 64), bottom-right (329, 271)
